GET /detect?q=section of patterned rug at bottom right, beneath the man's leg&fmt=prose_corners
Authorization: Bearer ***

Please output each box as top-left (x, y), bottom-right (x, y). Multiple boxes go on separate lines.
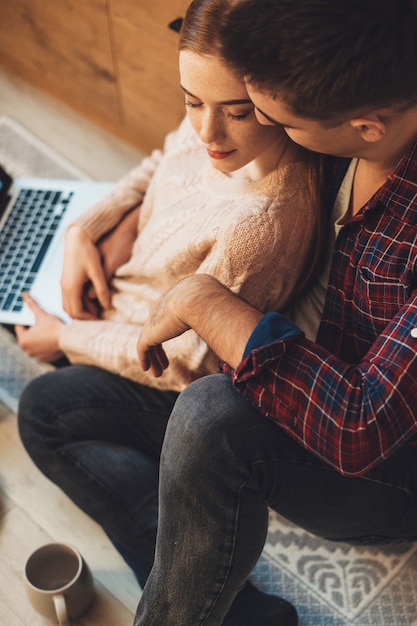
top-left (253, 513), bottom-right (417, 626)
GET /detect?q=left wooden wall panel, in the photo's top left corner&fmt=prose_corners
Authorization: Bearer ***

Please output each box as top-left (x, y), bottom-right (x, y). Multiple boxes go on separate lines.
top-left (0, 0), bottom-right (120, 120)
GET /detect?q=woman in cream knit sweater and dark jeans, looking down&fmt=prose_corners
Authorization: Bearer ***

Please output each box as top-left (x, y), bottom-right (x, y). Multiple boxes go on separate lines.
top-left (17, 0), bottom-right (322, 624)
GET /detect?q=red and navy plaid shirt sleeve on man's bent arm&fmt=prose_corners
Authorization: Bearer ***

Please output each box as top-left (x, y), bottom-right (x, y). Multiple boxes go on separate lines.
top-left (225, 295), bottom-right (417, 476)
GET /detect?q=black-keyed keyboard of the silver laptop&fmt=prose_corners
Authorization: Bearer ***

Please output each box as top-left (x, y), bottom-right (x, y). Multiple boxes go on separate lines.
top-left (0, 189), bottom-right (73, 312)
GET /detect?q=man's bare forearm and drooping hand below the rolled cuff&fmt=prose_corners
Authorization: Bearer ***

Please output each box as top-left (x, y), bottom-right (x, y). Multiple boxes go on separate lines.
top-left (137, 274), bottom-right (262, 376)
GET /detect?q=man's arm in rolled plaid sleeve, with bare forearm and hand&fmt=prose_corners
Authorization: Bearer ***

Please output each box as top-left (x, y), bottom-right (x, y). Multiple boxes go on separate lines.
top-left (138, 275), bottom-right (417, 476)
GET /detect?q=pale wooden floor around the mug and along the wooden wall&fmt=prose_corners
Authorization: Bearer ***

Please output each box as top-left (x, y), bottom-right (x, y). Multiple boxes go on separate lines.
top-left (0, 70), bottom-right (143, 626)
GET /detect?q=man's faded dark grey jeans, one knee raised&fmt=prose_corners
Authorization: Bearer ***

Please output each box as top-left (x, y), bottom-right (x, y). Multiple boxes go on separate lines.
top-left (135, 375), bottom-right (417, 626)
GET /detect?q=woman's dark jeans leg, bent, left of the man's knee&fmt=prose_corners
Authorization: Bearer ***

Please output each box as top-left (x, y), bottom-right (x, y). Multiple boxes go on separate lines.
top-left (18, 366), bottom-right (178, 585)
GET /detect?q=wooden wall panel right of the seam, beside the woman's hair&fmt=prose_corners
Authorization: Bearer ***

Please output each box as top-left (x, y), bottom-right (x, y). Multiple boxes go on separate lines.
top-left (108, 0), bottom-right (189, 150)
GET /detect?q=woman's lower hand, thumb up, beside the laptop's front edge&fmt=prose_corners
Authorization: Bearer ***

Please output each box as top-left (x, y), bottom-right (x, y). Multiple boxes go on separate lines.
top-left (15, 293), bottom-right (64, 363)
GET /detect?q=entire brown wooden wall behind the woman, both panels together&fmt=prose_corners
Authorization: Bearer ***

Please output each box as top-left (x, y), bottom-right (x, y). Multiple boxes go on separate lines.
top-left (0, 0), bottom-right (189, 152)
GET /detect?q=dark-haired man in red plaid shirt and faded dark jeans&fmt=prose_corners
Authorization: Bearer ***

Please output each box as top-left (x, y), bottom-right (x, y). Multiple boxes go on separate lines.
top-left (135, 0), bottom-right (417, 626)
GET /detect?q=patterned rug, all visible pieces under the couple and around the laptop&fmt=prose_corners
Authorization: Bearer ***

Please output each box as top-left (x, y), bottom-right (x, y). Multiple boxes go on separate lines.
top-left (0, 118), bottom-right (417, 626)
